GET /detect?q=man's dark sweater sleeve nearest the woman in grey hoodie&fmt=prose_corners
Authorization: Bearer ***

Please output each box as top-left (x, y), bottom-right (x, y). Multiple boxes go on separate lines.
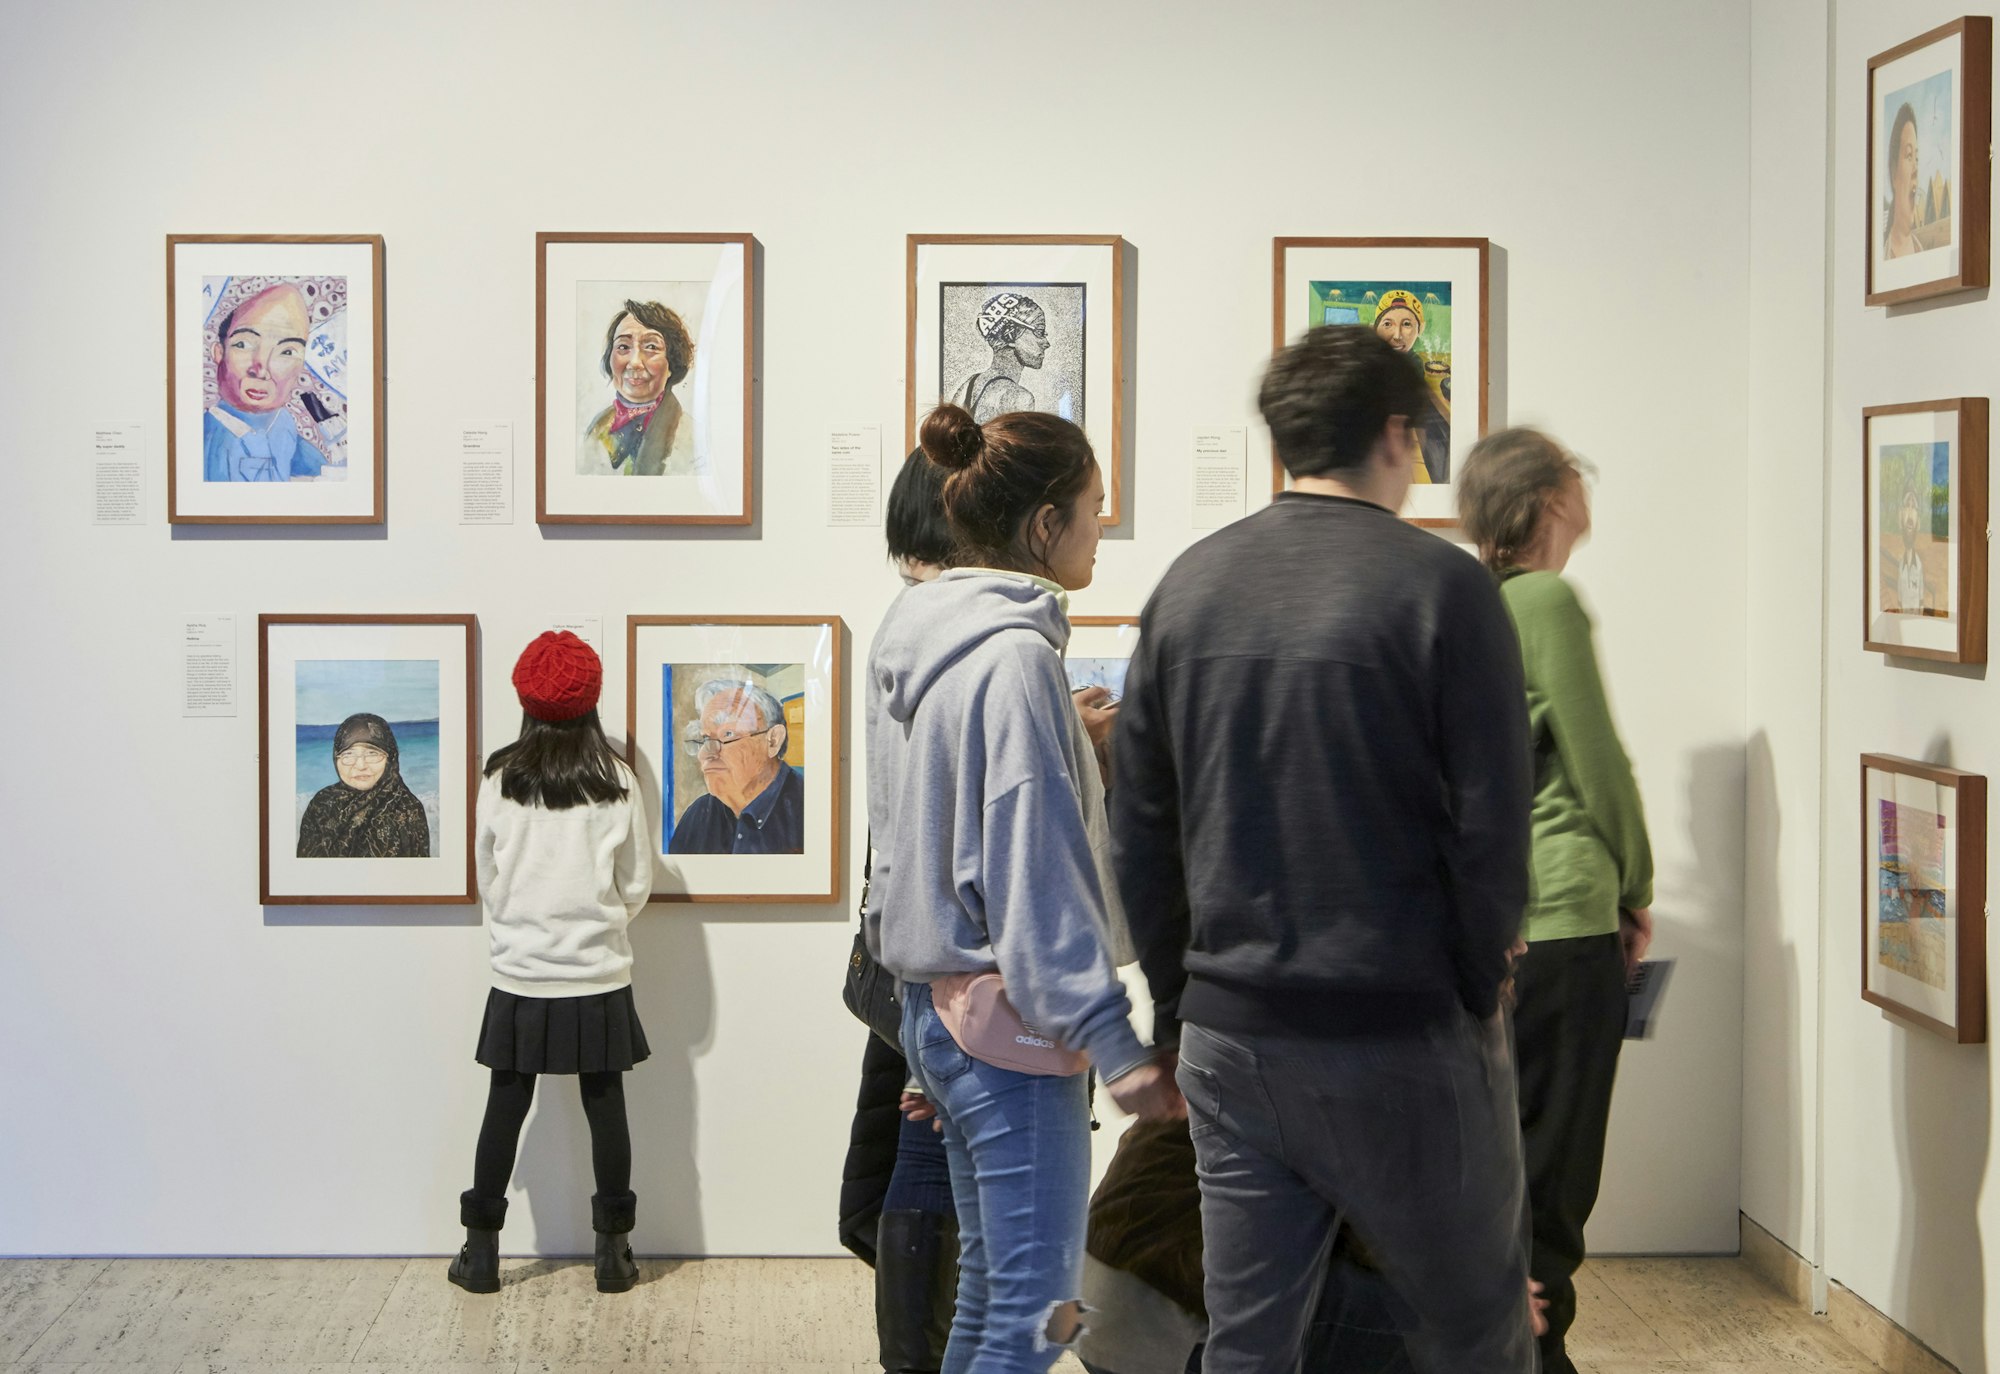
top-left (1112, 600), bottom-right (1190, 1046)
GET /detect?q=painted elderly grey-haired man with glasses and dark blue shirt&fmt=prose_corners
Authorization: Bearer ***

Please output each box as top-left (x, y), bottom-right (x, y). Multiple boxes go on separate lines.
top-left (666, 678), bottom-right (806, 854)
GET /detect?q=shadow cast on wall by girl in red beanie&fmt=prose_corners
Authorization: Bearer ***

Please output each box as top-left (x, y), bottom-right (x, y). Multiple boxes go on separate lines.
top-left (514, 906), bottom-right (716, 1256)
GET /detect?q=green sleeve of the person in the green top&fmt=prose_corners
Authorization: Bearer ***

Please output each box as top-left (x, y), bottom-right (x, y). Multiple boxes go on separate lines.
top-left (1524, 578), bottom-right (1652, 910)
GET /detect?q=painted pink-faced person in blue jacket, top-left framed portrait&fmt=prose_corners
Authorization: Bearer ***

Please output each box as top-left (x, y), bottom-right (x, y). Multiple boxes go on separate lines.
top-left (202, 282), bottom-right (328, 482)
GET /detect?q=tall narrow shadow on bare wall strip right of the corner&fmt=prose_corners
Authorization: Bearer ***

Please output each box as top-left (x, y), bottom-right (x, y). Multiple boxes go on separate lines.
top-left (1744, 730), bottom-right (1818, 1244)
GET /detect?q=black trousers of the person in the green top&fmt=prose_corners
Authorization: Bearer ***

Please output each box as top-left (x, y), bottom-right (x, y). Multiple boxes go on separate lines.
top-left (1514, 932), bottom-right (1626, 1374)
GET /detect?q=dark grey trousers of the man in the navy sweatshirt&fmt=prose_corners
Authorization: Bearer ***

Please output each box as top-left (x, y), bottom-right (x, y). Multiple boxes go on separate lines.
top-left (1180, 1014), bottom-right (1536, 1374)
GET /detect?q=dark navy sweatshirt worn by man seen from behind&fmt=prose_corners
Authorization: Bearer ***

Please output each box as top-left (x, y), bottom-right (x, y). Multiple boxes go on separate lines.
top-left (1112, 492), bottom-right (1532, 1044)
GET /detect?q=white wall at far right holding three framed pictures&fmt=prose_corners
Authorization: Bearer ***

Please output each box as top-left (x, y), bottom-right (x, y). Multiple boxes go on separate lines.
top-left (1832, 0), bottom-right (2000, 1370)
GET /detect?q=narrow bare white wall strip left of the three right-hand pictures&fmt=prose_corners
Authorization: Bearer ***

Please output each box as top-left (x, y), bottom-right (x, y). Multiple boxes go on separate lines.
top-left (1742, 0), bottom-right (1830, 1258)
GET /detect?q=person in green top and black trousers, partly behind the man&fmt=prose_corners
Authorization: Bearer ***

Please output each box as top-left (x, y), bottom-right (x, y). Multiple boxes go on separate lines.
top-left (1458, 430), bottom-right (1652, 1374)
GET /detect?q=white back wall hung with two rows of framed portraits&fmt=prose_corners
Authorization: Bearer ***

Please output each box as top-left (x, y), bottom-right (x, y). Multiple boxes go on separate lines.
top-left (0, 0), bottom-right (1752, 1254)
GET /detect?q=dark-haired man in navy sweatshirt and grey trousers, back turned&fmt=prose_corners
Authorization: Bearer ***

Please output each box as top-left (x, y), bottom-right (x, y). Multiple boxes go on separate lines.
top-left (1112, 326), bottom-right (1534, 1374)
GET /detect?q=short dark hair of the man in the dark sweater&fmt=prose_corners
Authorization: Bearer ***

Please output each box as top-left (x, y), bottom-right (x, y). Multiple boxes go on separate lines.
top-left (1256, 324), bottom-right (1434, 478)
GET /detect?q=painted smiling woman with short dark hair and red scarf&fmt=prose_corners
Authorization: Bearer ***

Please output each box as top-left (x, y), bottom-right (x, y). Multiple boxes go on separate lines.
top-left (576, 300), bottom-right (694, 478)
